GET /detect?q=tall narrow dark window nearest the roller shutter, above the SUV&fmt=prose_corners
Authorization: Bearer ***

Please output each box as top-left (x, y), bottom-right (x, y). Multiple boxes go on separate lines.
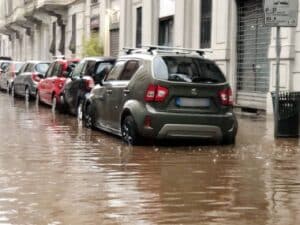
top-left (200, 0), bottom-right (212, 48)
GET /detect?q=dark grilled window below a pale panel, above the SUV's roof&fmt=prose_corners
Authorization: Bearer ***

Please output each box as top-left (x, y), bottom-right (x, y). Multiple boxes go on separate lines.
top-left (158, 16), bottom-right (174, 46)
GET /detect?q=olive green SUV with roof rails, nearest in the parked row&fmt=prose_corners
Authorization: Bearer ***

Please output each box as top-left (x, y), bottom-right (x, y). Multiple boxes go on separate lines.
top-left (83, 47), bottom-right (238, 145)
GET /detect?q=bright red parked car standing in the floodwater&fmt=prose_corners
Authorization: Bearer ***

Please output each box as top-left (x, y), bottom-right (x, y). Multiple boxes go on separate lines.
top-left (36, 59), bottom-right (80, 110)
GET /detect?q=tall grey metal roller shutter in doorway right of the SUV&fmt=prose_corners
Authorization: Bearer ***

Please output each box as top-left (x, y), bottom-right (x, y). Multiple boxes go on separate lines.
top-left (237, 0), bottom-right (271, 109)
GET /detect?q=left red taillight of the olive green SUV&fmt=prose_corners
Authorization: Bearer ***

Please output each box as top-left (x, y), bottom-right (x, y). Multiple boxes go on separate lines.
top-left (144, 84), bottom-right (169, 102)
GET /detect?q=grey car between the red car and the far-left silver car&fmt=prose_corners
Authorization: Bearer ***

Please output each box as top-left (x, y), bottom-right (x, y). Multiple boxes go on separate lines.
top-left (12, 61), bottom-right (50, 100)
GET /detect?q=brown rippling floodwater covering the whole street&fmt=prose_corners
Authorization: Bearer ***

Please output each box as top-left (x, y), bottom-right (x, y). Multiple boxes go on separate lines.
top-left (0, 93), bottom-right (300, 225)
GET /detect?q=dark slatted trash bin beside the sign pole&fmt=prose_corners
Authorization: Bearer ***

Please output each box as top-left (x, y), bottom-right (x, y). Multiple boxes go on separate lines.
top-left (271, 92), bottom-right (300, 137)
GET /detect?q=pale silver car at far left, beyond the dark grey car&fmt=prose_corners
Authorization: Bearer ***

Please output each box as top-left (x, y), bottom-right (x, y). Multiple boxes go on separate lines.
top-left (0, 62), bottom-right (24, 92)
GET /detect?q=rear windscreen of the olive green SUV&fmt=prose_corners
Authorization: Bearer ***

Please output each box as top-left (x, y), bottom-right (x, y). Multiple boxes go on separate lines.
top-left (154, 56), bottom-right (226, 83)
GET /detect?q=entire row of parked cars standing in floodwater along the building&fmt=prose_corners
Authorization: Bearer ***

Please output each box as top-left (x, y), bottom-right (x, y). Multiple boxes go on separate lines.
top-left (0, 46), bottom-right (238, 145)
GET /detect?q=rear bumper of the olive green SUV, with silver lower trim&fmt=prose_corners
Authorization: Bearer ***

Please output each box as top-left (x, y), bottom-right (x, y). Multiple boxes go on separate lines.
top-left (136, 107), bottom-right (238, 140)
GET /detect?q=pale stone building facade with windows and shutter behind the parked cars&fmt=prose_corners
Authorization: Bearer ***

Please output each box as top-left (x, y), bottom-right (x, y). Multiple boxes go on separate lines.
top-left (0, 0), bottom-right (300, 112)
